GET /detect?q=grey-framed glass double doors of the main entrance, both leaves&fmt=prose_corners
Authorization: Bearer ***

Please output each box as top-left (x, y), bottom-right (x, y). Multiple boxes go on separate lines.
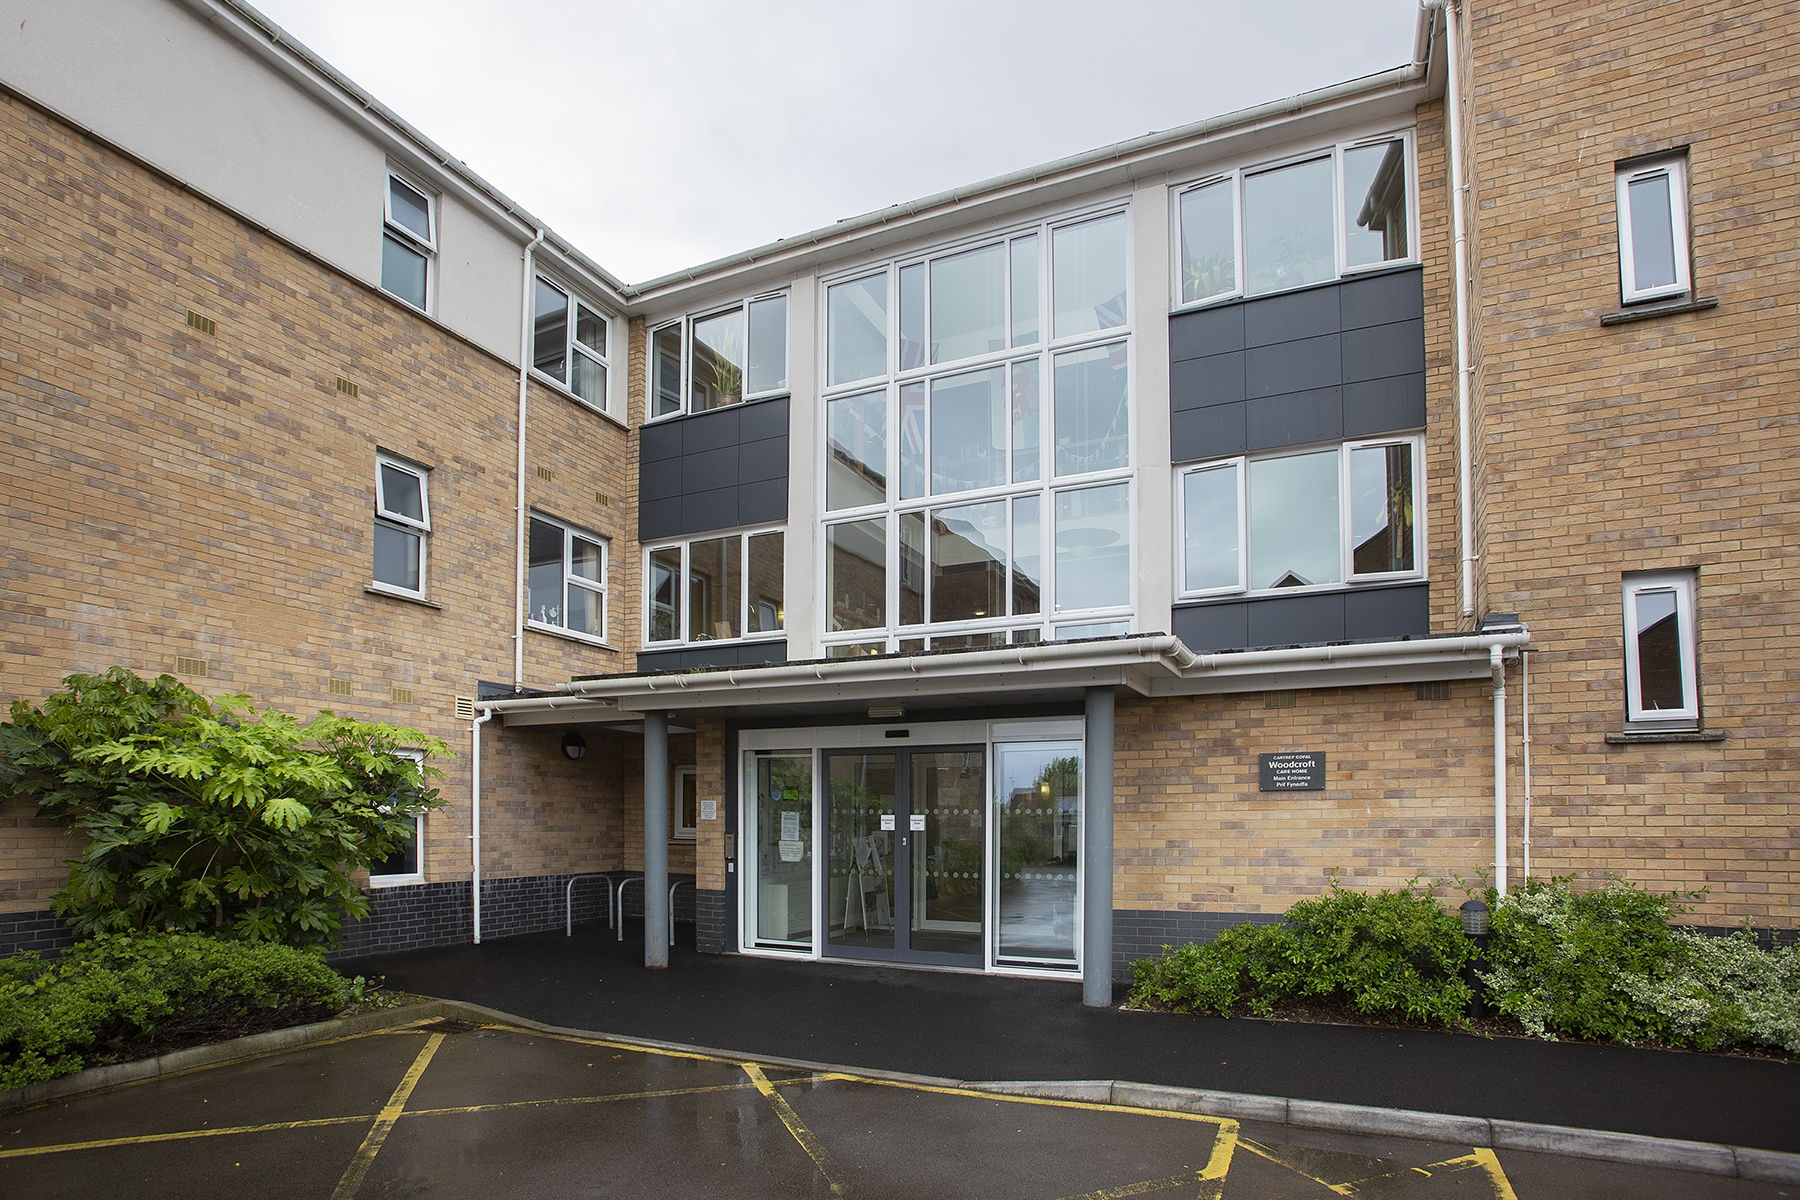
top-left (823, 747), bottom-right (986, 966)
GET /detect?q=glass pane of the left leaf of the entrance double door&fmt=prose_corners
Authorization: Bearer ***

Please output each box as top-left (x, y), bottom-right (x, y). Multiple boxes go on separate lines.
top-left (824, 754), bottom-right (898, 950)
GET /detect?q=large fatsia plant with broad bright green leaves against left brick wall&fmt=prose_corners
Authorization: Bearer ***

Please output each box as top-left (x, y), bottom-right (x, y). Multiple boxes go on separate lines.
top-left (0, 667), bottom-right (446, 946)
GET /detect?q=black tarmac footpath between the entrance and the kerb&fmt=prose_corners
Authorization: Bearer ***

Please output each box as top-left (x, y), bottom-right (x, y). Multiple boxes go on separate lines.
top-left (338, 925), bottom-right (1800, 1153)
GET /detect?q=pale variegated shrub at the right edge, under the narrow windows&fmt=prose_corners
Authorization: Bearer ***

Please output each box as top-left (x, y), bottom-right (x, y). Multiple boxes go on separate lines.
top-left (1481, 878), bottom-right (1800, 1052)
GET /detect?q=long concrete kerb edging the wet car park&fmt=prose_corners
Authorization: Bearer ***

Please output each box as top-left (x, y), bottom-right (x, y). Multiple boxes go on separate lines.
top-left (0, 1000), bottom-right (1800, 1184)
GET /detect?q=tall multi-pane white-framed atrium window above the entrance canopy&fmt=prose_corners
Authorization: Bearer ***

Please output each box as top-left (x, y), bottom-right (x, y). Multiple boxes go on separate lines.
top-left (819, 212), bottom-right (1132, 657)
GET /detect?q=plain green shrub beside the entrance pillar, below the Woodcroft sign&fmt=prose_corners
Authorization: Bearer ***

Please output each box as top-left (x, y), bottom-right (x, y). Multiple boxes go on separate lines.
top-left (1132, 878), bottom-right (1474, 1024)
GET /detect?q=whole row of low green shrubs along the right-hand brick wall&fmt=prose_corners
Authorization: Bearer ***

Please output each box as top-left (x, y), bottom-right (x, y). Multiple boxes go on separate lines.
top-left (1130, 878), bottom-right (1800, 1054)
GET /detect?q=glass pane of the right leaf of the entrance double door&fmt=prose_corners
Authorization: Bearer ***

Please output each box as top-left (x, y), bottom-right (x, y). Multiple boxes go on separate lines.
top-left (907, 752), bottom-right (986, 955)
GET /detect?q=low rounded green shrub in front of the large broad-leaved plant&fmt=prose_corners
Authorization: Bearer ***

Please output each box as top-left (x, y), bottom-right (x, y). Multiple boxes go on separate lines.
top-left (0, 934), bottom-right (347, 1088)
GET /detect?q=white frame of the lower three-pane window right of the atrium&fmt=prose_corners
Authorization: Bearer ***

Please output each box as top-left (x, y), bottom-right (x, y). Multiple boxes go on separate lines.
top-left (1174, 434), bottom-right (1429, 599)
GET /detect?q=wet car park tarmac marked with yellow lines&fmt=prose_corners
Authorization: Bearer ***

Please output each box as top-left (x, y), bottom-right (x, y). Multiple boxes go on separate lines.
top-left (0, 1022), bottom-right (1793, 1200)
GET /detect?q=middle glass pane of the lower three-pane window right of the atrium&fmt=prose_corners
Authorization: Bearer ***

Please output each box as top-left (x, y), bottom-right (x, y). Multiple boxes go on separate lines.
top-left (1249, 450), bottom-right (1343, 588)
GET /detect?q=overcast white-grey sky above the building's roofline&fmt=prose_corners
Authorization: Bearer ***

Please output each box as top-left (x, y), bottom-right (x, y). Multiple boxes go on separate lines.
top-left (252, 0), bottom-right (1418, 282)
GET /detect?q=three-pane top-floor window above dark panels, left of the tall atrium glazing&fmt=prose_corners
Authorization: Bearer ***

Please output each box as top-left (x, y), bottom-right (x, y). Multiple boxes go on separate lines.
top-left (650, 295), bottom-right (787, 417)
